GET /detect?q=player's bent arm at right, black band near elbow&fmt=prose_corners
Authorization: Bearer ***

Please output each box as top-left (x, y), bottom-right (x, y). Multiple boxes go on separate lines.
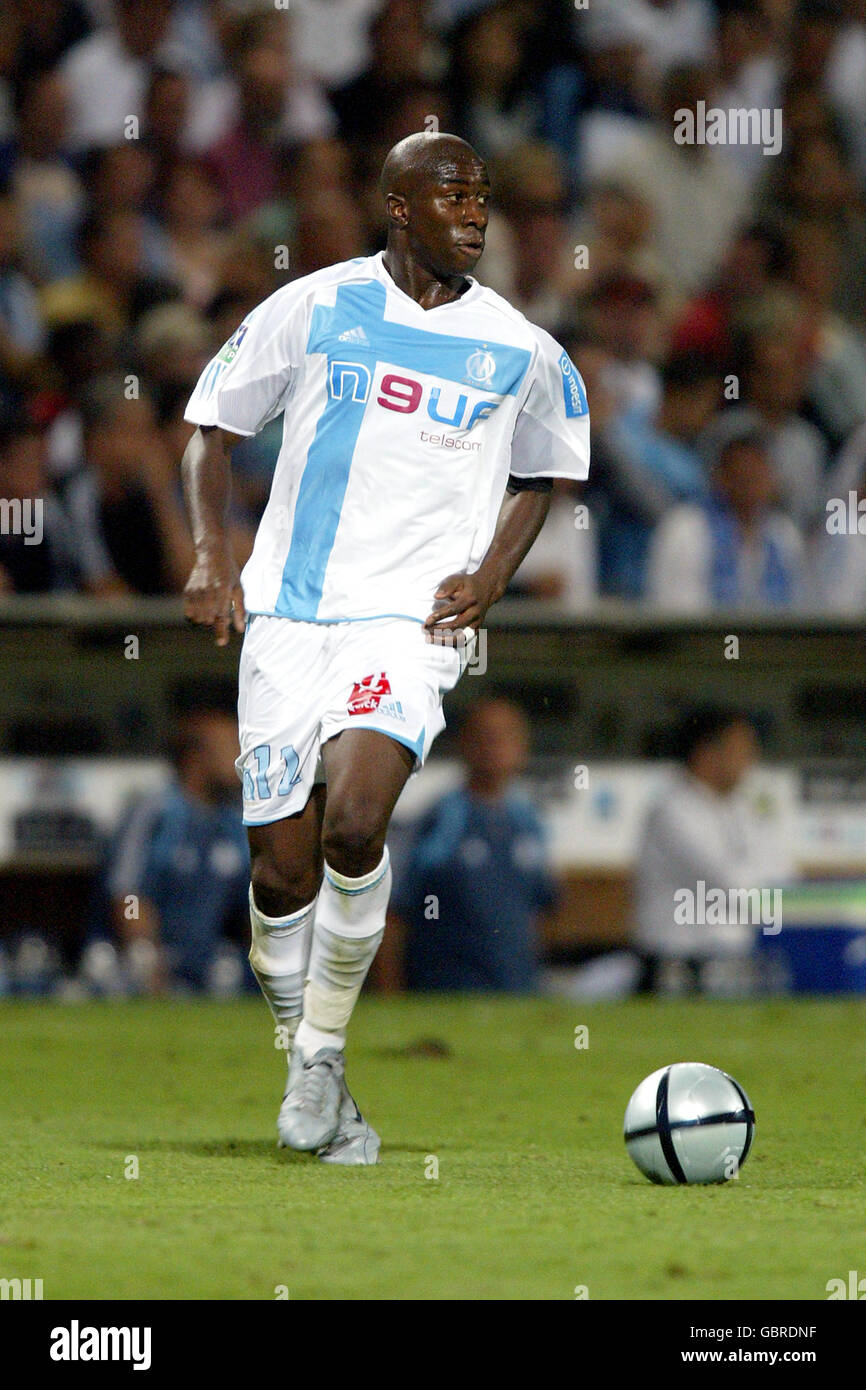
top-left (424, 477), bottom-right (553, 631)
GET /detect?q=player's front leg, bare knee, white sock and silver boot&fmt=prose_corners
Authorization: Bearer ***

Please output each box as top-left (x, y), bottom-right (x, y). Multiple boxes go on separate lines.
top-left (281, 728), bottom-right (416, 1150)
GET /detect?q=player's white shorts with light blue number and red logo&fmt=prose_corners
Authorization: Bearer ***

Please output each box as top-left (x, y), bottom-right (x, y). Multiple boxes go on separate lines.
top-left (235, 613), bottom-right (475, 826)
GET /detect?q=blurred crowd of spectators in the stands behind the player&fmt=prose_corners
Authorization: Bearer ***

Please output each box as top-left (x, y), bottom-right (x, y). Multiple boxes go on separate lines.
top-left (0, 0), bottom-right (866, 613)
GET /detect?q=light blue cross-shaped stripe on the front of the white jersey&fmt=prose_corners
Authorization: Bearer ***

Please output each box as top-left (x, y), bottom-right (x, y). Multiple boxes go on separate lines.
top-left (275, 279), bottom-right (531, 621)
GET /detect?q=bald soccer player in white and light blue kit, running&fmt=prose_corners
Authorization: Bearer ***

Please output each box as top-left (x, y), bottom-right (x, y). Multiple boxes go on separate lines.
top-left (182, 132), bottom-right (589, 1163)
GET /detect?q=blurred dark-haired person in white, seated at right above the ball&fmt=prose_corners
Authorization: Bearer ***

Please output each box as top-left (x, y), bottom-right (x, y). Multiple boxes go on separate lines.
top-left (632, 706), bottom-right (792, 992)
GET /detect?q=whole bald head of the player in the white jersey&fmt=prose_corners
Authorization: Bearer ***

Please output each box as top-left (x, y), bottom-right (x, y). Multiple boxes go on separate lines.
top-left (379, 132), bottom-right (491, 281)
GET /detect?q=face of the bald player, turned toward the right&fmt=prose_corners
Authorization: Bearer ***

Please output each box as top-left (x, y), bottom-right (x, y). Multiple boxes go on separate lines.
top-left (407, 156), bottom-right (491, 279)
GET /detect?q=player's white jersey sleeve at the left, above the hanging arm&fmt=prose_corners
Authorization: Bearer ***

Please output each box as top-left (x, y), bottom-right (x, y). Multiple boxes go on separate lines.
top-left (183, 285), bottom-right (309, 435)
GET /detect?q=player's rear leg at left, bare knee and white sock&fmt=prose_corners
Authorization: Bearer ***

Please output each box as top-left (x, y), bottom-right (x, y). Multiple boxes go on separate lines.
top-left (247, 784), bottom-right (325, 1049)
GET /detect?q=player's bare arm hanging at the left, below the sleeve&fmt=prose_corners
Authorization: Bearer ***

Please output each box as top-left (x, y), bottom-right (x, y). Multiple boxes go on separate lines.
top-left (181, 425), bottom-right (246, 646)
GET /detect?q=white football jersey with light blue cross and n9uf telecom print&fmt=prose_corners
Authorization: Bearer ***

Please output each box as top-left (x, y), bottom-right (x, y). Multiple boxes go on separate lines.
top-left (185, 252), bottom-right (589, 623)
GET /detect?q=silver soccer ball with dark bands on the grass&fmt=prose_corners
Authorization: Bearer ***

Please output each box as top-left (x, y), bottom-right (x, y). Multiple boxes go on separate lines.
top-left (623, 1062), bottom-right (755, 1186)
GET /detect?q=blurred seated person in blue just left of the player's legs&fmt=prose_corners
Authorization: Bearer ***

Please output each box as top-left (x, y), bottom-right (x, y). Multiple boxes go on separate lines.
top-left (82, 708), bottom-right (250, 994)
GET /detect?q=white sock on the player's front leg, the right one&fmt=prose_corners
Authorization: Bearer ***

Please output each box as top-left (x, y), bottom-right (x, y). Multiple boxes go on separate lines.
top-left (296, 848), bottom-right (391, 1056)
